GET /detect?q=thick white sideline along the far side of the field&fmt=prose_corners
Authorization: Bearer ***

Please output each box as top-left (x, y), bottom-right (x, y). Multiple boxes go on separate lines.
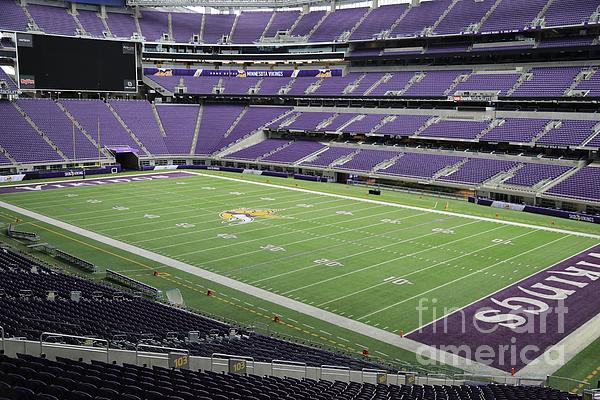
top-left (185, 172), bottom-right (600, 239)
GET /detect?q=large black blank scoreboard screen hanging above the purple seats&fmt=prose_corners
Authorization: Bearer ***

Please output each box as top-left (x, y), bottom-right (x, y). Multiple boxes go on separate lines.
top-left (17, 33), bottom-right (137, 93)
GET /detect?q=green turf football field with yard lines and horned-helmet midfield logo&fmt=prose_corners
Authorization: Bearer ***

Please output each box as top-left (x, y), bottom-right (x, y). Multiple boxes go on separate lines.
top-left (0, 172), bottom-right (600, 384)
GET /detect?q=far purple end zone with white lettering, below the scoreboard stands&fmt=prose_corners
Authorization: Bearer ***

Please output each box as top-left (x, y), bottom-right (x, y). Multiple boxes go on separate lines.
top-left (0, 172), bottom-right (191, 194)
